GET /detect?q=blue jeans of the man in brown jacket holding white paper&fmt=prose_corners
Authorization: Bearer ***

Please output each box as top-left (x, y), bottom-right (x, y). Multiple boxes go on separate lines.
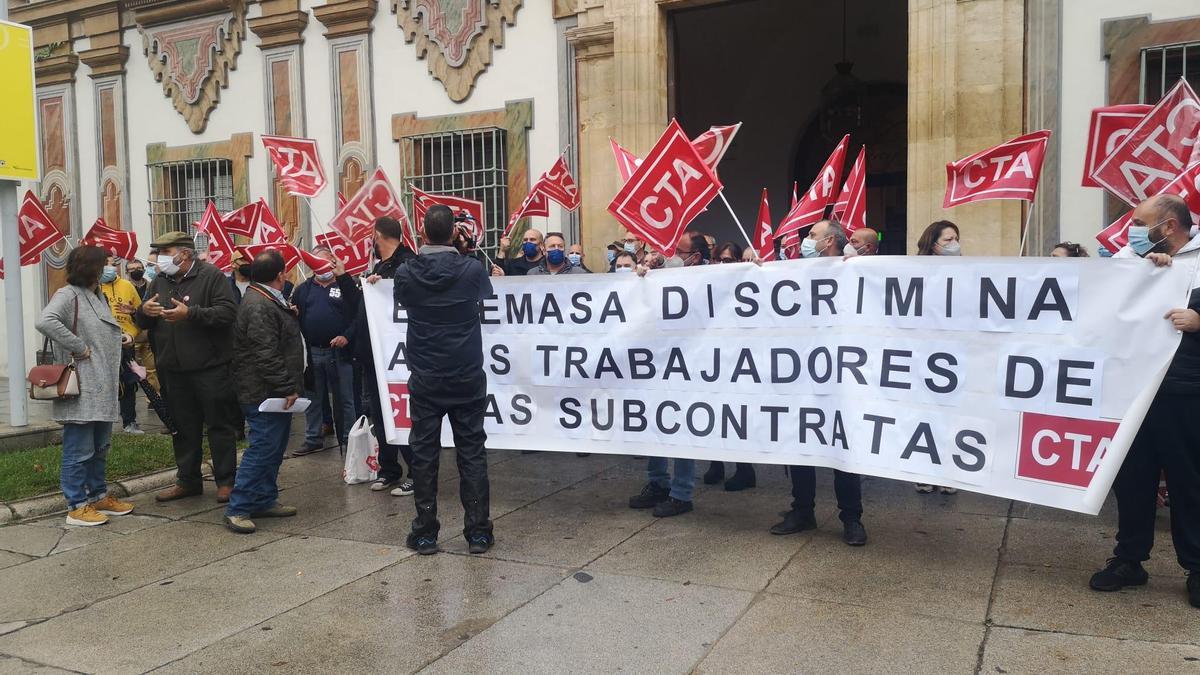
top-left (226, 405), bottom-right (295, 515)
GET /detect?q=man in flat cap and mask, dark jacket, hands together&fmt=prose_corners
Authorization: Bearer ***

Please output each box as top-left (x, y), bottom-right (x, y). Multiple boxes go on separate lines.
top-left (137, 232), bottom-right (239, 503)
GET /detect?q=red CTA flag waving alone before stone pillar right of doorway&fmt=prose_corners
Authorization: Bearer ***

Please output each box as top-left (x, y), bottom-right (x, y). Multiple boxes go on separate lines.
top-left (942, 131), bottom-right (1050, 209)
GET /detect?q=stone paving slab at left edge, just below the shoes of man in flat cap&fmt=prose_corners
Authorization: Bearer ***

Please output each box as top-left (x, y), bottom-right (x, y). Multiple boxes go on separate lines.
top-left (0, 522), bottom-right (278, 619)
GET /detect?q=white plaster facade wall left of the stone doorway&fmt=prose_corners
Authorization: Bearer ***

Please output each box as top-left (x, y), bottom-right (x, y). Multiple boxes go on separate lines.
top-left (0, 0), bottom-right (560, 384)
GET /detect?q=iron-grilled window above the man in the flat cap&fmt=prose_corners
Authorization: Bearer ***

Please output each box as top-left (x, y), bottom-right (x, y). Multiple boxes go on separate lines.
top-left (146, 159), bottom-right (233, 239)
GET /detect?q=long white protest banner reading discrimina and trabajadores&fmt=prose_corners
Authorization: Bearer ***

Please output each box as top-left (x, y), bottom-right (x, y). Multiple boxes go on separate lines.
top-left (365, 256), bottom-right (1194, 513)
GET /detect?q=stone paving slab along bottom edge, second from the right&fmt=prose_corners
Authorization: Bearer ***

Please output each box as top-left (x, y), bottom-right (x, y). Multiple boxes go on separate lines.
top-left (696, 595), bottom-right (984, 675)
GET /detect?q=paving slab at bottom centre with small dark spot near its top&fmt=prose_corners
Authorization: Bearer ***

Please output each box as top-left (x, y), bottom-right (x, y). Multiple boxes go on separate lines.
top-left (422, 572), bottom-right (754, 675)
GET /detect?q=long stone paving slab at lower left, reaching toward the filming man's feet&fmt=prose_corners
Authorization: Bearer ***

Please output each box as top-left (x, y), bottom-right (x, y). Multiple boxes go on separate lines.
top-left (0, 534), bottom-right (408, 673)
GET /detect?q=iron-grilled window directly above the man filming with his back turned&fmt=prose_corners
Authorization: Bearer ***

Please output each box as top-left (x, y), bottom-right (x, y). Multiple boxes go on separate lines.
top-left (400, 127), bottom-right (509, 250)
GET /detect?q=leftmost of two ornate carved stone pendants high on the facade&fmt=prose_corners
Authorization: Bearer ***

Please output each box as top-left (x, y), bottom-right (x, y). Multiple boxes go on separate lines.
top-left (140, 0), bottom-right (246, 133)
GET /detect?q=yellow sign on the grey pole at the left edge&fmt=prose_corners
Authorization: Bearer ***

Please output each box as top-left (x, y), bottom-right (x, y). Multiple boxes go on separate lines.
top-left (0, 19), bottom-right (41, 180)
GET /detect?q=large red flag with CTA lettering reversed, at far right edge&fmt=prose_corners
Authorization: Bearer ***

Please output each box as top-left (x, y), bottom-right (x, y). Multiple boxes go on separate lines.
top-left (1091, 79), bottom-right (1200, 205)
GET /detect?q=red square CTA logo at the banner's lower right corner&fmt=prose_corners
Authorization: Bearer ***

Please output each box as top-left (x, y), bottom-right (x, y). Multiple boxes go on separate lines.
top-left (1016, 412), bottom-right (1121, 488)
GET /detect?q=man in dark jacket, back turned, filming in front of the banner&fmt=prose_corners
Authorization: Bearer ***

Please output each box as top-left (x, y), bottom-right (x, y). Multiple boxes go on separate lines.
top-left (395, 205), bottom-right (494, 555)
